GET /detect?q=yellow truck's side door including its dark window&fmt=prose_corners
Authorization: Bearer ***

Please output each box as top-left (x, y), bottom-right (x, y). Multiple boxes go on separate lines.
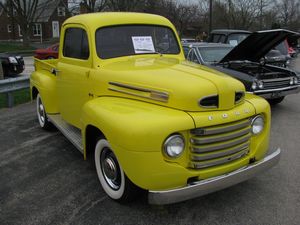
top-left (57, 24), bottom-right (92, 128)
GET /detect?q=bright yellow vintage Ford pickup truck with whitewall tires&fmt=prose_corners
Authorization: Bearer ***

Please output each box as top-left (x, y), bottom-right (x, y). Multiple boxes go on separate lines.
top-left (30, 13), bottom-right (280, 204)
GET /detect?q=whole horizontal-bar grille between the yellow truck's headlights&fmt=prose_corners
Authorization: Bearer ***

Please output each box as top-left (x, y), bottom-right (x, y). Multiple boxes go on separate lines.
top-left (189, 119), bottom-right (251, 169)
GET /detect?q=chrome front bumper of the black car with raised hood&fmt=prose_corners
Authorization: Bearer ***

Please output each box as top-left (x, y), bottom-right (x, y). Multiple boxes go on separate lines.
top-left (249, 85), bottom-right (300, 99)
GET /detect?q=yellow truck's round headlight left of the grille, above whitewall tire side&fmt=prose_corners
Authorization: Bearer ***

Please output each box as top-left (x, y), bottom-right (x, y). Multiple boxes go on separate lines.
top-left (164, 134), bottom-right (184, 158)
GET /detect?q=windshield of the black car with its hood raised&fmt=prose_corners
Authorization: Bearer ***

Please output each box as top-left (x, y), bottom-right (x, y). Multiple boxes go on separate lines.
top-left (198, 47), bottom-right (232, 63)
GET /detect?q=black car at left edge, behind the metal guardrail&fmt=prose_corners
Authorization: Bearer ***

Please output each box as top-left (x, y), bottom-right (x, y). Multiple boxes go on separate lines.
top-left (0, 53), bottom-right (25, 76)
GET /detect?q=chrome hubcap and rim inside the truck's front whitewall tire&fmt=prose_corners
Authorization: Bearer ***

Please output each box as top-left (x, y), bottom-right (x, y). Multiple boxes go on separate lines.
top-left (100, 148), bottom-right (121, 190)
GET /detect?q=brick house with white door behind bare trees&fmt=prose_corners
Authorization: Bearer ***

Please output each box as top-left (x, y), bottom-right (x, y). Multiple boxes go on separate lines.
top-left (0, 0), bottom-right (68, 41)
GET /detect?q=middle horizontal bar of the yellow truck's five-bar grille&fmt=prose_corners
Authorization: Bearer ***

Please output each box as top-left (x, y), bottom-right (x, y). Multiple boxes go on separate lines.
top-left (191, 134), bottom-right (251, 153)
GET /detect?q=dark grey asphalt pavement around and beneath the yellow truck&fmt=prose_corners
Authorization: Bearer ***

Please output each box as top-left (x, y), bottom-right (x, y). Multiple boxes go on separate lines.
top-left (0, 59), bottom-right (300, 225)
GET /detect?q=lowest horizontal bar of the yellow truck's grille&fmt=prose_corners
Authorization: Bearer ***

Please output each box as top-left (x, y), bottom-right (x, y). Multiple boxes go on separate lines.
top-left (190, 147), bottom-right (249, 169)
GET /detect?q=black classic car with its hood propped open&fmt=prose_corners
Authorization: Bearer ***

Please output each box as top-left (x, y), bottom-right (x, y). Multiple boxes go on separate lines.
top-left (183, 29), bottom-right (300, 104)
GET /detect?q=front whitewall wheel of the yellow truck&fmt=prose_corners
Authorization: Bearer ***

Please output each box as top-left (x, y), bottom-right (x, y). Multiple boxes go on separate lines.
top-left (95, 139), bottom-right (140, 202)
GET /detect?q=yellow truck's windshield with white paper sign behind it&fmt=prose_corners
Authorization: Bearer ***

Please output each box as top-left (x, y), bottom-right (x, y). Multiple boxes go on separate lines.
top-left (96, 25), bottom-right (180, 59)
